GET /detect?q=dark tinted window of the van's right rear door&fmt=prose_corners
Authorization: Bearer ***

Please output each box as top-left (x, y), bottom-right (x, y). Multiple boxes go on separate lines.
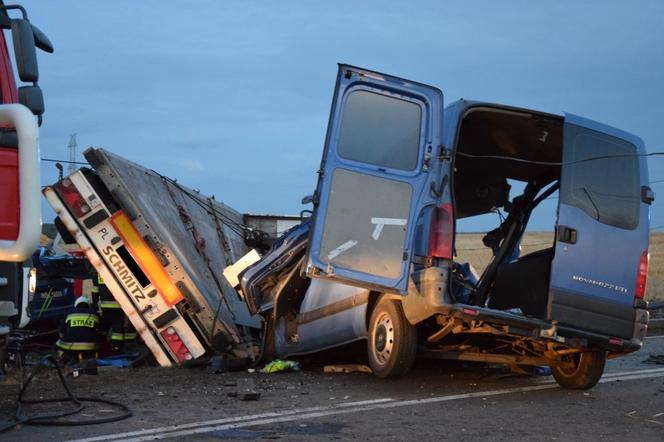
top-left (560, 124), bottom-right (640, 230)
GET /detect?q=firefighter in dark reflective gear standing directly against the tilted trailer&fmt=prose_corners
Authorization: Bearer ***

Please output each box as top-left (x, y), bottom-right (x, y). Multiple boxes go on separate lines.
top-left (92, 276), bottom-right (137, 353)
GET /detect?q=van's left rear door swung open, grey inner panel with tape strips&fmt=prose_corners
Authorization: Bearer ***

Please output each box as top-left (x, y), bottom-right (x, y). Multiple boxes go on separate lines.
top-left (306, 65), bottom-right (443, 293)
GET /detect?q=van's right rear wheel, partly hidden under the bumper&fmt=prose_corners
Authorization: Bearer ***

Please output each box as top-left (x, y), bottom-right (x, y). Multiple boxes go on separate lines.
top-left (551, 351), bottom-right (606, 390)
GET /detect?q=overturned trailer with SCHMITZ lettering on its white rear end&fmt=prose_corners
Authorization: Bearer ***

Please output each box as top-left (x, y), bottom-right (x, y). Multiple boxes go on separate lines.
top-left (44, 149), bottom-right (282, 366)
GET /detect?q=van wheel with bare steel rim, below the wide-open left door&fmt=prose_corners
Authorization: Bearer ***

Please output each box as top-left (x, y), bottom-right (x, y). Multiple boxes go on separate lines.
top-left (368, 299), bottom-right (417, 378)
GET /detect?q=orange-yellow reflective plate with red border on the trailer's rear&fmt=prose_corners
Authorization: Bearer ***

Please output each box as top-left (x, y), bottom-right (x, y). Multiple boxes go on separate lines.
top-left (111, 210), bottom-right (183, 306)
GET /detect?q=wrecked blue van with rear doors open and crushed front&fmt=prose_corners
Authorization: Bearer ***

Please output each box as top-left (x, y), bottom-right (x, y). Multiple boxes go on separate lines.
top-left (241, 65), bottom-right (654, 389)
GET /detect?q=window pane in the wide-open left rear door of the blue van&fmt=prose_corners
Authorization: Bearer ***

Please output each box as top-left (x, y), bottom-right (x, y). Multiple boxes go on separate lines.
top-left (337, 90), bottom-right (422, 170)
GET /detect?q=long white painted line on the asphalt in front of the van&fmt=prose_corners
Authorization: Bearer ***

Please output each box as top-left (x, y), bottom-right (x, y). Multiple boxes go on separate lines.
top-left (68, 369), bottom-right (664, 442)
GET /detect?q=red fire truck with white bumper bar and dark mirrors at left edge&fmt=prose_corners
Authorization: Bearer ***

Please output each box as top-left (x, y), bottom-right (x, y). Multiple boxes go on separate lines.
top-left (0, 1), bottom-right (53, 348)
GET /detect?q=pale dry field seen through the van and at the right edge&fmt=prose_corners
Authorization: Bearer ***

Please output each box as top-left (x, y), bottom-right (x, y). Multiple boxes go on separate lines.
top-left (456, 232), bottom-right (664, 301)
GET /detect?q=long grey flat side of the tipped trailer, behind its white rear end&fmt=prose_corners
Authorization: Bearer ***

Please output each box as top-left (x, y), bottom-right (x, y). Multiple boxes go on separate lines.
top-left (84, 149), bottom-right (260, 334)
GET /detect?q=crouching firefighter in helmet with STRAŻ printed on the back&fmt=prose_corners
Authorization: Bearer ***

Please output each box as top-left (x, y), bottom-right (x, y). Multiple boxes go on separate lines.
top-left (55, 296), bottom-right (100, 362)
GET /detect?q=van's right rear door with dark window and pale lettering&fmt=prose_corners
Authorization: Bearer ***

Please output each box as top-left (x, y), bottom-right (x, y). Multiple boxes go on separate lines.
top-left (549, 114), bottom-right (652, 338)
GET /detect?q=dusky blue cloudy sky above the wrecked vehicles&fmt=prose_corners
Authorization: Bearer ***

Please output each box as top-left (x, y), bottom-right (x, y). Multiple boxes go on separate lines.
top-left (15, 0), bottom-right (664, 231)
